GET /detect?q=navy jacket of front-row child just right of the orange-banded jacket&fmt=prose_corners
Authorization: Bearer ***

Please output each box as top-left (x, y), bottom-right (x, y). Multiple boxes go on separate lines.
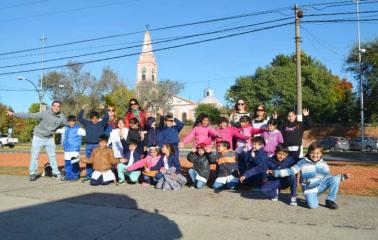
top-left (244, 147), bottom-right (268, 178)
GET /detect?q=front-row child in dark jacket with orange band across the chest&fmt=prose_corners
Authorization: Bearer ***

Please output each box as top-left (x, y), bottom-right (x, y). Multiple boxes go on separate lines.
top-left (213, 141), bottom-right (239, 189)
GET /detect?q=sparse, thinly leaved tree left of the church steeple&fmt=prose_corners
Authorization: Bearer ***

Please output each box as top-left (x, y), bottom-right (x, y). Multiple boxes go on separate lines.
top-left (43, 62), bottom-right (127, 114)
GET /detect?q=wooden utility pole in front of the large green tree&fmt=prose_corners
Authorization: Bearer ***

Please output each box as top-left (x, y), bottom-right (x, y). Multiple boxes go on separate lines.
top-left (294, 4), bottom-right (303, 122)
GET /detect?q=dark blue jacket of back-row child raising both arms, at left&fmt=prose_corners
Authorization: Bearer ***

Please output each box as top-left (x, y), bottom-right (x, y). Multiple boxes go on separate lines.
top-left (77, 110), bottom-right (109, 144)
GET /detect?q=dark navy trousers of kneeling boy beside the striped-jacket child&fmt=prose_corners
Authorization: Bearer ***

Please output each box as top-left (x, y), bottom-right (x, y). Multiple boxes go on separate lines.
top-left (261, 176), bottom-right (297, 198)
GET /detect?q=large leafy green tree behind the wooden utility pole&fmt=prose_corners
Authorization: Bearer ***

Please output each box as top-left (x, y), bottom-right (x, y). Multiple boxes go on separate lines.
top-left (226, 53), bottom-right (343, 122)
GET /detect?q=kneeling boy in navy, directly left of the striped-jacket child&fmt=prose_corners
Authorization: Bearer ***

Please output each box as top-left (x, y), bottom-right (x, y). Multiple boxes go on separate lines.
top-left (261, 144), bottom-right (297, 206)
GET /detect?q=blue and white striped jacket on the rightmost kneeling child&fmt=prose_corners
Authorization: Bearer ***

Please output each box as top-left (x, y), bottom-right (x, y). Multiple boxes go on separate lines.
top-left (273, 157), bottom-right (331, 191)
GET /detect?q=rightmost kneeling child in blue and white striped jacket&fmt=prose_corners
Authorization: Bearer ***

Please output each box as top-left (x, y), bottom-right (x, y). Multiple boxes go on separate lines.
top-left (268, 143), bottom-right (351, 209)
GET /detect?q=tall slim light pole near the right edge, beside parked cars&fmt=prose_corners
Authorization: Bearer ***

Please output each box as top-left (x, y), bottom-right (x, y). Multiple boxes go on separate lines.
top-left (356, 0), bottom-right (366, 152)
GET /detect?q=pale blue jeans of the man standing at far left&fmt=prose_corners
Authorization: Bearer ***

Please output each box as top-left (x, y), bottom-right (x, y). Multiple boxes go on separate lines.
top-left (29, 136), bottom-right (60, 175)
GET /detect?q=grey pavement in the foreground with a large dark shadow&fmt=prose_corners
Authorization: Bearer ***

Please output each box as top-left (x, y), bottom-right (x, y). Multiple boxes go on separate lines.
top-left (0, 175), bottom-right (378, 239)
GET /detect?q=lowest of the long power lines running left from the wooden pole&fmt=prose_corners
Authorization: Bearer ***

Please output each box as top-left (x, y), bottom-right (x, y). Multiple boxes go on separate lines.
top-left (0, 22), bottom-right (293, 76)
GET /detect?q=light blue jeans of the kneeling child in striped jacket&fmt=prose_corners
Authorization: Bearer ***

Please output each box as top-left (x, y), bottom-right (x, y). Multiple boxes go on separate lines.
top-left (304, 175), bottom-right (341, 208)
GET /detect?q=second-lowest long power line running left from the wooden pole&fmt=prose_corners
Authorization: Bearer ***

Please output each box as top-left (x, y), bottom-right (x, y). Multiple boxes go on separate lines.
top-left (0, 17), bottom-right (292, 68)
